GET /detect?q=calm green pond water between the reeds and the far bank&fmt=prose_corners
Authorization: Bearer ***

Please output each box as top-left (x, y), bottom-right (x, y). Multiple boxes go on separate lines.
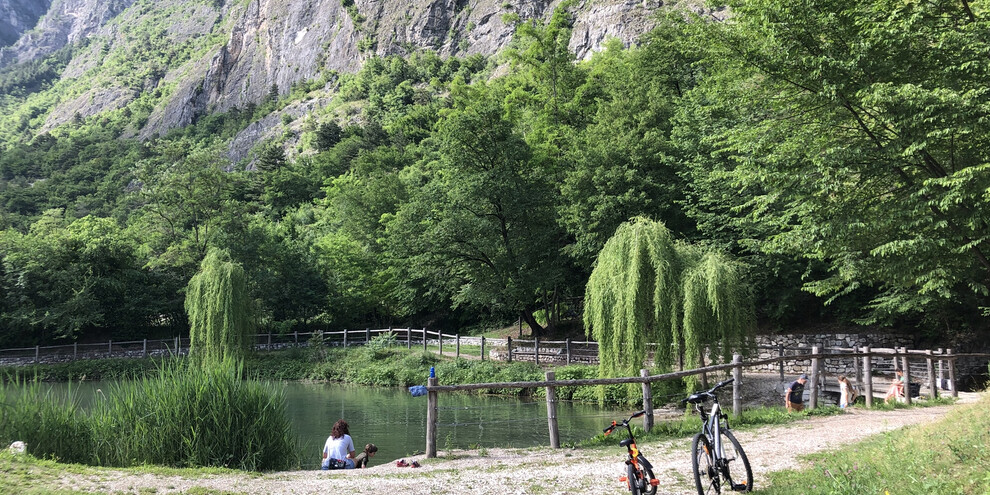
top-left (21, 382), bottom-right (630, 469)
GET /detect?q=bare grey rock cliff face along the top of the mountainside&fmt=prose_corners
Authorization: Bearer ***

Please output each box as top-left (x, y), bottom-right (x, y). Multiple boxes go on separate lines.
top-left (0, 0), bottom-right (660, 143)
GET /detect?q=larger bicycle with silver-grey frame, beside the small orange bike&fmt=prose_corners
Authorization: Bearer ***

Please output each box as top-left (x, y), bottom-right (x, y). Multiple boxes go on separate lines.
top-left (681, 378), bottom-right (753, 495)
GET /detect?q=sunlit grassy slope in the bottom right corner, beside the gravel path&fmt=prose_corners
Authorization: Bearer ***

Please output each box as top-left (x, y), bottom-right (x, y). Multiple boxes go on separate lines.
top-left (756, 395), bottom-right (990, 495)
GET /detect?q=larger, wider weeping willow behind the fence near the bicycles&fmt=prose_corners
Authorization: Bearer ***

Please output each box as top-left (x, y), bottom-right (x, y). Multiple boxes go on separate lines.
top-left (584, 217), bottom-right (755, 376)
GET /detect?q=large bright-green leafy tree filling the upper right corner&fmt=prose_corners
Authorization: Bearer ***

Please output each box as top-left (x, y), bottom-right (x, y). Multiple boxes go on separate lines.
top-left (696, 0), bottom-right (990, 328)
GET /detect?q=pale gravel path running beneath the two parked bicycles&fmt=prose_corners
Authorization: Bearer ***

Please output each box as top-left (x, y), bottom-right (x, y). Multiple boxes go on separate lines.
top-left (52, 394), bottom-right (978, 495)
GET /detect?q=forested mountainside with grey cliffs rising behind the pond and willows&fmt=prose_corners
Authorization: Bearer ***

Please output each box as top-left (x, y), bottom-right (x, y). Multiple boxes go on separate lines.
top-left (0, 0), bottom-right (990, 352)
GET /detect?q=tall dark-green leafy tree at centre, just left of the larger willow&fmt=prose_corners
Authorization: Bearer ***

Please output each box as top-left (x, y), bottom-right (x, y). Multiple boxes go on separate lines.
top-left (388, 87), bottom-right (563, 335)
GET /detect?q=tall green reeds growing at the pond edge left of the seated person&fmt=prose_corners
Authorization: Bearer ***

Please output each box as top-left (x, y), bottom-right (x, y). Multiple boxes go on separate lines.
top-left (0, 362), bottom-right (299, 471)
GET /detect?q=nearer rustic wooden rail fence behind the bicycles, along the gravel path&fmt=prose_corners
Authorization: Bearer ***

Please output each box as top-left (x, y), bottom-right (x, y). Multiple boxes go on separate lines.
top-left (426, 347), bottom-right (990, 457)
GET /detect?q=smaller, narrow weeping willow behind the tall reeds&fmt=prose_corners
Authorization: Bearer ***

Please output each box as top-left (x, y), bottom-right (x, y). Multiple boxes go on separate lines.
top-left (186, 249), bottom-right (254, 364)
